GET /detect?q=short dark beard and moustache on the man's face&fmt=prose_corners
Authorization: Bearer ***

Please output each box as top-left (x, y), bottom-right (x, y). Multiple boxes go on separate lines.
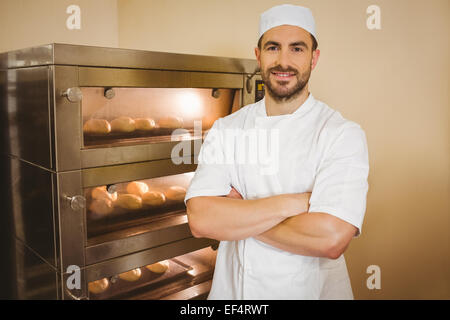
top-left (261, 65), bottom-right (311, 102)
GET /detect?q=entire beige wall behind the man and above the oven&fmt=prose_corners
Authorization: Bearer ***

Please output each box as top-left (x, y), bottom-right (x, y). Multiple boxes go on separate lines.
top-left (0, 0), bottom-right (450, 299)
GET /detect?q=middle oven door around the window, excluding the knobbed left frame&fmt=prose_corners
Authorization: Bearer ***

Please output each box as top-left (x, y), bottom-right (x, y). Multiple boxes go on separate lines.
top-left (82, 157), bottom-right (196, 265)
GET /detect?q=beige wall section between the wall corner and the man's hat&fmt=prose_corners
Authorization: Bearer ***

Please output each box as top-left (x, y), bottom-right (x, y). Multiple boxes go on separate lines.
top-left (118, 0), bottom-right (264, 58)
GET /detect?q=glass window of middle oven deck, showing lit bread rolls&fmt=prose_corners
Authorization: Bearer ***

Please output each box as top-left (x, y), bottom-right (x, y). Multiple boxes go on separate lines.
top-left (84, 172), bottom-right (194, 239)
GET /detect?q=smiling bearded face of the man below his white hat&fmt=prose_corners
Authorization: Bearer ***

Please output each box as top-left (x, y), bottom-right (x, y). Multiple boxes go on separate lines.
top-left (255, 25), bottom-right (318, 102)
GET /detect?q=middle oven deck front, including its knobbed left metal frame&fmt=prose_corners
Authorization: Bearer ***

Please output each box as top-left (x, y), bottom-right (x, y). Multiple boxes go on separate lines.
top-left (58, 157), bottom-right (217, 297)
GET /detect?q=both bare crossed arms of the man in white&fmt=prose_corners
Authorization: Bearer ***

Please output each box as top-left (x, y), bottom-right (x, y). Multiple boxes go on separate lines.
top-left (186, 188), bottom-right (357, 259)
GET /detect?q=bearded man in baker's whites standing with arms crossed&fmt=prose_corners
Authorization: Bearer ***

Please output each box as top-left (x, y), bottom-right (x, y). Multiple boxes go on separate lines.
top-left (185, 5), bottom-right (369, 299)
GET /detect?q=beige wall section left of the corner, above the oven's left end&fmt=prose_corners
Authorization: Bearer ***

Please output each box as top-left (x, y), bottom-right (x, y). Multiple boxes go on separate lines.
top-left (0, 0), bottom-right (119, 52)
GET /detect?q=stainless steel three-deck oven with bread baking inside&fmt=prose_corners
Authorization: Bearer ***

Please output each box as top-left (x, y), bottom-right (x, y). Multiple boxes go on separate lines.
top-left (0, 44), bottom-right (262, 299)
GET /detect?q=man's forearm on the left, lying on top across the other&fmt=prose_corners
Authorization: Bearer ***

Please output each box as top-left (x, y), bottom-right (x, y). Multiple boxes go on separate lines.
top-left (187, 195), bottom-right (305, 240)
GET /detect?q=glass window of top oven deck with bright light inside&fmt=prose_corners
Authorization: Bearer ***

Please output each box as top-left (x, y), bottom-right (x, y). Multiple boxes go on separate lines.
top-left (81, 87), bottom-right (240, 148)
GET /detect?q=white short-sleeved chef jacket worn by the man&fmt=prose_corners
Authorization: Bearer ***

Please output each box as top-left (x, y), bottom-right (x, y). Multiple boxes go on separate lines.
top-left (185, 94), bottom-right (369, 300)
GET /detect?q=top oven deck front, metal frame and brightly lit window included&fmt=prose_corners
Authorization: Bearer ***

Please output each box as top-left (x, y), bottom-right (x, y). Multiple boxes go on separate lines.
top-left (53, 66), bottom-right (245, 171)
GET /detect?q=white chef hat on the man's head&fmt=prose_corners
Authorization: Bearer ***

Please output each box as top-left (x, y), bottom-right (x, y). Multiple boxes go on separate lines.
top-left (259, 4), bottom-right (317, 40)
